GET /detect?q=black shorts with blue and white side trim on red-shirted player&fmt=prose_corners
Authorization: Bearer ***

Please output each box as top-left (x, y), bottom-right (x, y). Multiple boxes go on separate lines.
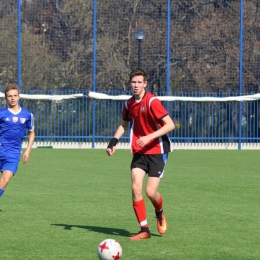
top-left (131, 153), bottom-right (168, 178)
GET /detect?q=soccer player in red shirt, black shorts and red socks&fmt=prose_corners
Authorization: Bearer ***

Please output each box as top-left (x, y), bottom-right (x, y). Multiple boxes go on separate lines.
top-left (106, 68), bottom-right (175, 240)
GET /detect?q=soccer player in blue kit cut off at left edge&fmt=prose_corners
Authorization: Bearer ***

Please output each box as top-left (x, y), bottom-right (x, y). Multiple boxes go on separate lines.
top-left (0, 85), bottom-right (35, 197)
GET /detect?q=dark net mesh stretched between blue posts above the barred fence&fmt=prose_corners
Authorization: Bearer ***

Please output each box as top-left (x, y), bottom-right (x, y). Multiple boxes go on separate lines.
top-left (0, 0), bottom-right (260, 91)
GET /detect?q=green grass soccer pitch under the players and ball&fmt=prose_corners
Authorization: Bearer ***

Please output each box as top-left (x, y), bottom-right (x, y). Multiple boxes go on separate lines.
top-left (0, 149), bottom-right (260, 260)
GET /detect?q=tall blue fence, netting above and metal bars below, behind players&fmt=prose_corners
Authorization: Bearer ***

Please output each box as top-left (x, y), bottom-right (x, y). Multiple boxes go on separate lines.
top-left (0, 0), bottom-right (260, 147)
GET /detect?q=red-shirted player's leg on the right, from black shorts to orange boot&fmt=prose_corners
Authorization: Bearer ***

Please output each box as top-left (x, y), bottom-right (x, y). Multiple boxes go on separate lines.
top-left (146, 154), bottom-right (168, 234)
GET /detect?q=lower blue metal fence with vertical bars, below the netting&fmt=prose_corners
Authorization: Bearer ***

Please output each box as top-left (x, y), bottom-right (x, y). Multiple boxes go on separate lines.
top-left (1, 90), bottom-right (260, 144)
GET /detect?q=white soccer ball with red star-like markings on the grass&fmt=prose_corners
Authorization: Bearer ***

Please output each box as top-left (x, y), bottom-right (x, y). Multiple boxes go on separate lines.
top-left (97, 238), bottom-right (122, 260)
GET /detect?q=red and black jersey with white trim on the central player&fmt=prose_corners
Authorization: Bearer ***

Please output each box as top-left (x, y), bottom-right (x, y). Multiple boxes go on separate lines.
top-left (122, 92), bottom-right (171, 154)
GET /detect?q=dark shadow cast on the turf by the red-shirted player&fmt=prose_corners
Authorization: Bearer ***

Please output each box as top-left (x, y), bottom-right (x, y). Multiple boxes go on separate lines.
top-left (51, 224), bottom-right (160, 237)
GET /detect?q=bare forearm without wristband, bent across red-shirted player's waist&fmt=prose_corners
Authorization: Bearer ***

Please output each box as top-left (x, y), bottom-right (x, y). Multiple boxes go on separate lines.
top-left (136, 115), bottom-right (175, 147)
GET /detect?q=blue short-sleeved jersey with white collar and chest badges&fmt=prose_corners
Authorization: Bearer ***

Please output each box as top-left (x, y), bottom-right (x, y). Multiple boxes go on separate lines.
top-left (0, 108), bottom-right (34, 160)
